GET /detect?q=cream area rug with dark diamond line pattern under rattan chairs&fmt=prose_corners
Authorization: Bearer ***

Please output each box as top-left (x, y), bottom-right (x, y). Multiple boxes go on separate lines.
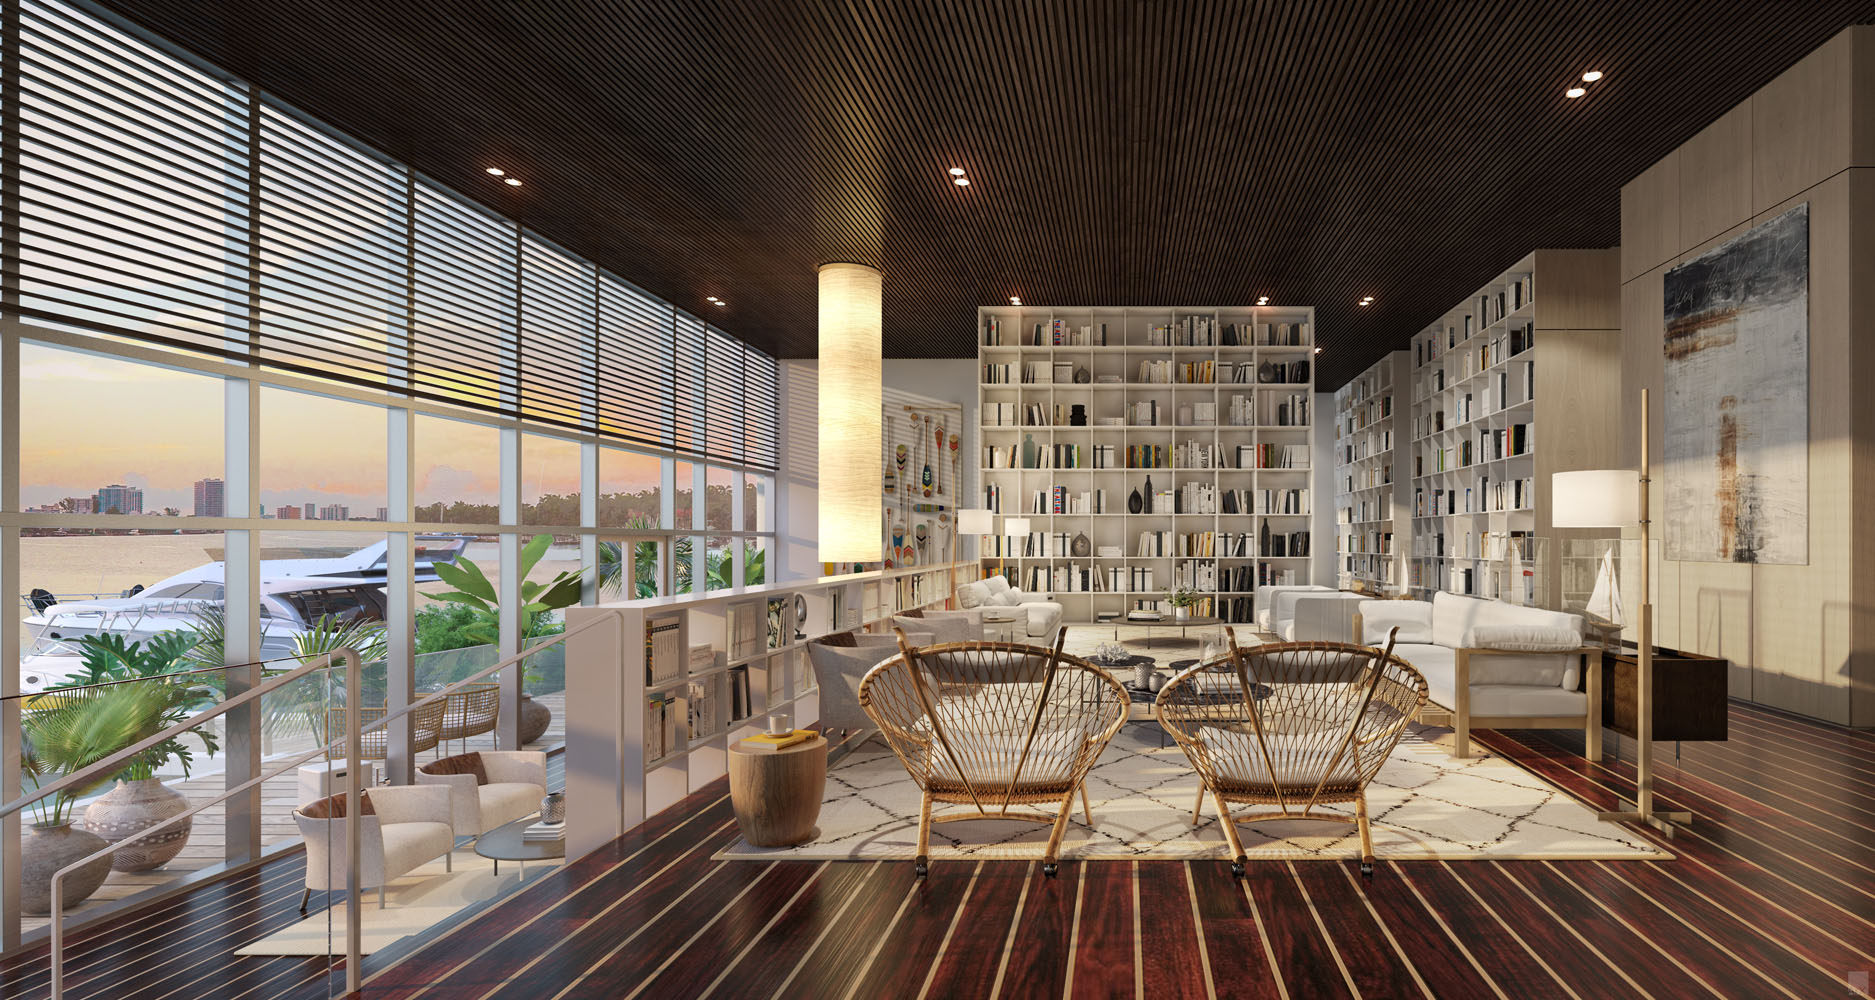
top-left (718, 722), bottom-right (1671, 861)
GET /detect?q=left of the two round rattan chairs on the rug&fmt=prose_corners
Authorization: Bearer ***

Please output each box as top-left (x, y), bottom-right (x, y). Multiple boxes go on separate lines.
top-left (859, 632), bottom-right (1129, 878)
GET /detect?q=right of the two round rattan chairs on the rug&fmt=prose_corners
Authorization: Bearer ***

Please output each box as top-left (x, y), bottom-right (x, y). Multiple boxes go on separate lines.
top-left (1155, 629), bottom-right (1427, 878)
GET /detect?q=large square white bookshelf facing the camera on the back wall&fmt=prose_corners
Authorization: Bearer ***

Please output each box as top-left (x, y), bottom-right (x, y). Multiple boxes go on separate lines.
top-left (977, 306), bottom-right (1328, 621)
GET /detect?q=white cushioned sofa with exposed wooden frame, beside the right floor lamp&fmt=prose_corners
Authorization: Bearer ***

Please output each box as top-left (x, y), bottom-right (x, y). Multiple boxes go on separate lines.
top-left (1356, 593), bottom-right (1601, 760)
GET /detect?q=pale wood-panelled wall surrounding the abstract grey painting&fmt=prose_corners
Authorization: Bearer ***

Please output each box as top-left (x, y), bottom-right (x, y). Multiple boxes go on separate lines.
top-left (1622, 28), bottom-right (1875, 726)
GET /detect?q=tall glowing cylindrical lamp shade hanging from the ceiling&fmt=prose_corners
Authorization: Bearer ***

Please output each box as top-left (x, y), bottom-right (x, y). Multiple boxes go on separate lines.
top-left (819, 265), bottom-right (885, 563)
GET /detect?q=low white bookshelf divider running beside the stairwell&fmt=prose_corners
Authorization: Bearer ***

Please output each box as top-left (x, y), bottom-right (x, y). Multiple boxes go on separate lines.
top-left (566, 563), bottom-right (977, 856)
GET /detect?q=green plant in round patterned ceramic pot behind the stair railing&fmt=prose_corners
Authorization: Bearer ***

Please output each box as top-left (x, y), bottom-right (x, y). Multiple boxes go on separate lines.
top-left (62, 632), bottom-right (219, 872)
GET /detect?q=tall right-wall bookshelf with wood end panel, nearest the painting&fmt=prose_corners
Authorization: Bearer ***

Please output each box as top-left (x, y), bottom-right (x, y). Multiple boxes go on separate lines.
top-left (1408, 248), bottom-right (1622, 606)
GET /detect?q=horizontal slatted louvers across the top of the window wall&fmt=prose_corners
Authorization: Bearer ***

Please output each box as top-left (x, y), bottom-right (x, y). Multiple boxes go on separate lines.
top-left (0, 0), bottom-right (778, 467)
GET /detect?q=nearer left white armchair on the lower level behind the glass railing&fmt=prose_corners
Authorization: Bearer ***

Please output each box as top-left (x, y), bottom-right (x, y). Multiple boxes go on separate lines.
top-left (293, 784), bottom-right (456, 914)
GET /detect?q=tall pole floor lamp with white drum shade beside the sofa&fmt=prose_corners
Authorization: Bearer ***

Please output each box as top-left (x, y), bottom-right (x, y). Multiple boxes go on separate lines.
top-left (1549, 388), bottom-right (1693, 837)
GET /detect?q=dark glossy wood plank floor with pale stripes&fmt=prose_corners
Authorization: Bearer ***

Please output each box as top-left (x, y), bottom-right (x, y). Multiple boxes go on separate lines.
top-left (0, 704), bottom-right (1875, 1000)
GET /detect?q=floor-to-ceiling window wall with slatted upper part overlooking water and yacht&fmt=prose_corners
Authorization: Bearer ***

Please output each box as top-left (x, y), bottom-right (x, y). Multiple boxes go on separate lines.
top-left (0, 2), bottom-right (778, 946)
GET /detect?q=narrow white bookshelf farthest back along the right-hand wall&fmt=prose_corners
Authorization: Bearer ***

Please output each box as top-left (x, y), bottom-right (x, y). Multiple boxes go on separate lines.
top-left (1335, 351), bottom-right (1412, 593)
